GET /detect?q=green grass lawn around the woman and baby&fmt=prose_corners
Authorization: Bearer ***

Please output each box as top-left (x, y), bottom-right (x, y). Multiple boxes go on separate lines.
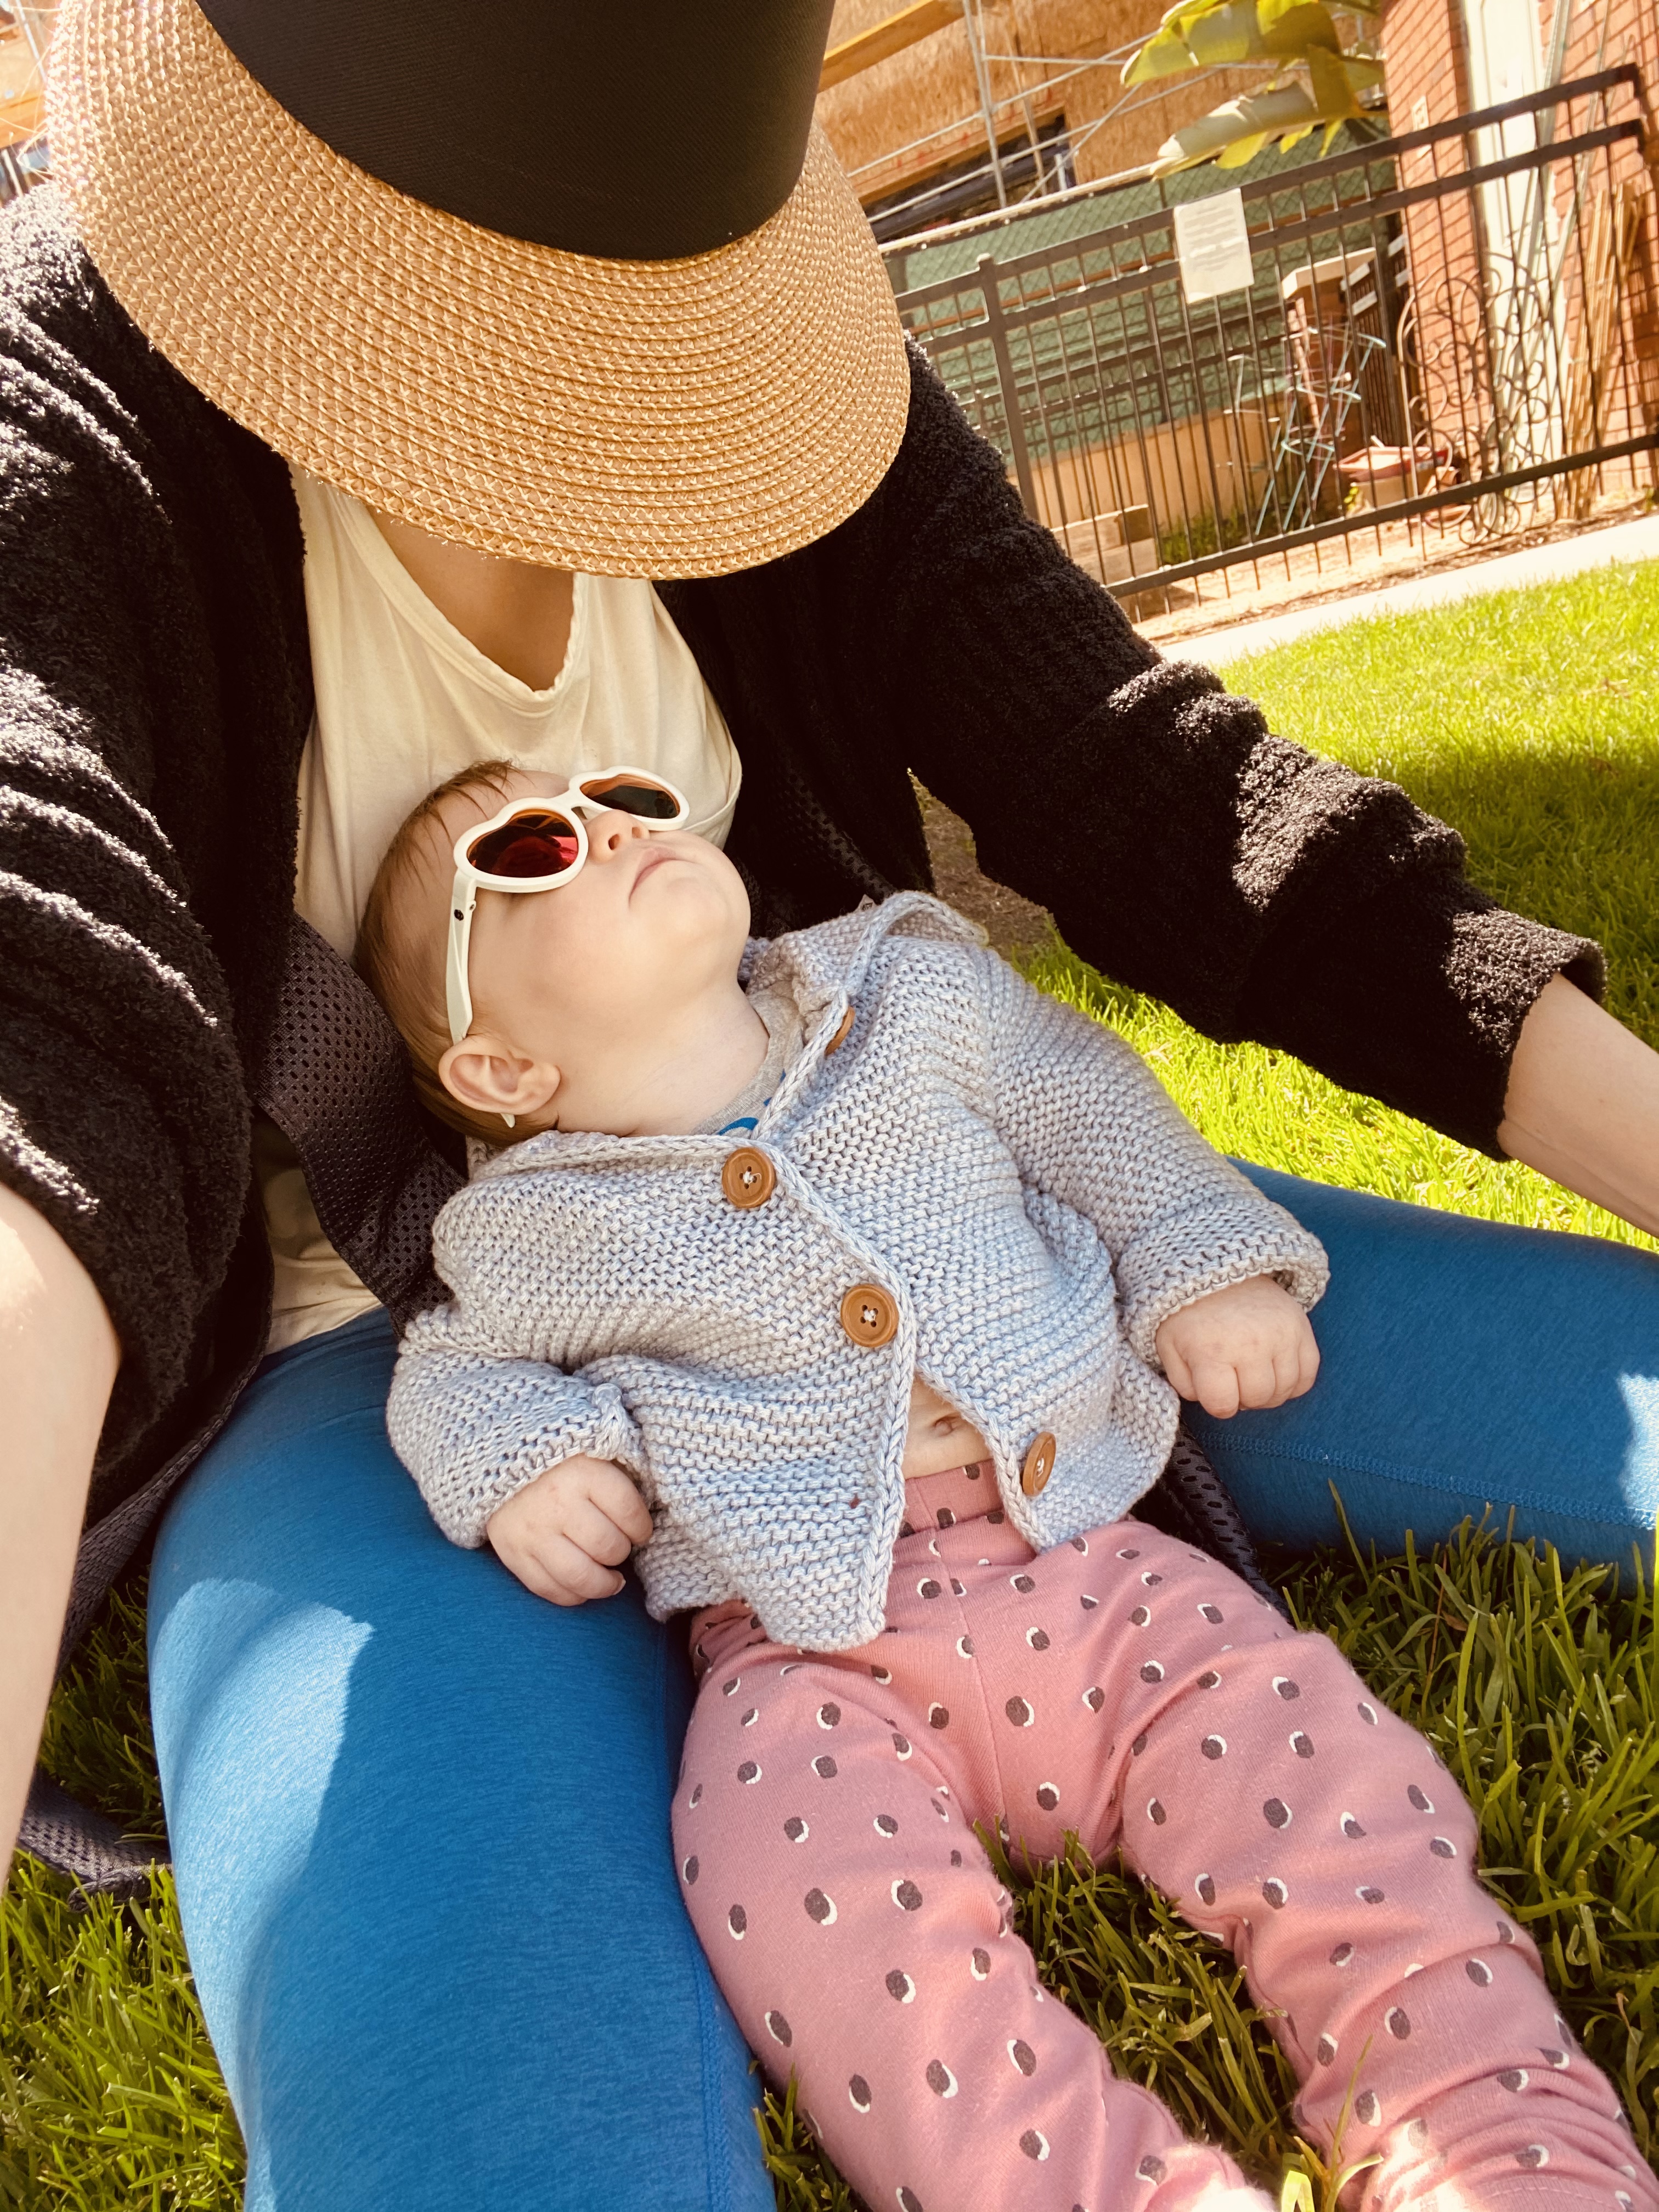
top-left (0, 562), bottom-right (1659, 2212)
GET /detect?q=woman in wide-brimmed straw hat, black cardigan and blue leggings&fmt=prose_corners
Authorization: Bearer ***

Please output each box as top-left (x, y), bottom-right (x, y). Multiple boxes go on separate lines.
top-left (0, 0), bottom-right (1659, 2212)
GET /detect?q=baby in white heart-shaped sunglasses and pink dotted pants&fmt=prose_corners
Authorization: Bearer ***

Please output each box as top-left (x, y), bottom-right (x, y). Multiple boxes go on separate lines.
top-left (358, 763), bottom-right (1659, 2212)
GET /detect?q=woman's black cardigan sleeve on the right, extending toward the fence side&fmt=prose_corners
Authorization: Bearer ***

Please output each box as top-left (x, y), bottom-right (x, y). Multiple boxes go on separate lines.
top-left (858, 356), bottom-right (1601, 1153)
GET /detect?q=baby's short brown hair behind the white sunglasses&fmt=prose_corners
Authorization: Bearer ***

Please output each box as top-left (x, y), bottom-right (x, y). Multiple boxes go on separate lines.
top-left (352, 761), bottom-right (529, 1146)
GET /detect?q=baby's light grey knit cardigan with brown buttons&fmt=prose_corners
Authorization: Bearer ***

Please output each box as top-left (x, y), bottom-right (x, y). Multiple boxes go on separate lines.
top-left (387, 894), bottom-right (1325, 1650)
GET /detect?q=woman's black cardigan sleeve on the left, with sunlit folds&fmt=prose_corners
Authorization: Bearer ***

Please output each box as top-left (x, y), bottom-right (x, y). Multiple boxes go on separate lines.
top-left (0, 193), bottom-right (309, 1473)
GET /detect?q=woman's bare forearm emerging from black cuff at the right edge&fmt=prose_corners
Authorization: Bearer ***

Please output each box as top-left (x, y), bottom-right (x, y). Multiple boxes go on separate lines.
top-left (1498, 975), bottom-right (1659, 1237)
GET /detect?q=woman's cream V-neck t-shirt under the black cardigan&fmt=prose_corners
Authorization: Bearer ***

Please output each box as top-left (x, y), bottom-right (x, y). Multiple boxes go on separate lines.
top-left (255, 469), bottom-right (741, 1352)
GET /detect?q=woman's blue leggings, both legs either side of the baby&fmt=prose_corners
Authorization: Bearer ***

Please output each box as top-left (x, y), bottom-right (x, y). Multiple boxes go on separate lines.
top-left (150, 1170), bottom-right (1659, 2212)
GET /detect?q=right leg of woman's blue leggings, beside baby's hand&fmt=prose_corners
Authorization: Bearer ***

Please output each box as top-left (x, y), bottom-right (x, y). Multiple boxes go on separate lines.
top-left (1188, 1161), bottom-right (1659, 1582)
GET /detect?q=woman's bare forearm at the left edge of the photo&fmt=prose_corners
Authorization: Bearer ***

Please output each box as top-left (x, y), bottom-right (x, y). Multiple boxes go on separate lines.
top-left (0, 1186), bottom-right (120, 1860)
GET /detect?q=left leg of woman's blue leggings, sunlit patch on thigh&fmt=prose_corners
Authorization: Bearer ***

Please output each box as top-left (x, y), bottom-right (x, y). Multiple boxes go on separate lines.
top-left (150, 1314), bottom-right (772, 2212)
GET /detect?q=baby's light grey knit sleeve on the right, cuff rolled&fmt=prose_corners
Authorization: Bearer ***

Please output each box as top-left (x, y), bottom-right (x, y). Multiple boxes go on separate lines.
top-left (980, 953), bottom-right (1329, 1367)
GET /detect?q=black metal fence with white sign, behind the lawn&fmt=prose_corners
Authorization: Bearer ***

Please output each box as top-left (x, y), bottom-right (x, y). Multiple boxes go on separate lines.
top-left (898, 66), bottom-right (1659, 597)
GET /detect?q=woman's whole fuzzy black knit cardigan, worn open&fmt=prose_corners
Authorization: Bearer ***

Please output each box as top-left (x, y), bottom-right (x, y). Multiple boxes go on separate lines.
top-left (0, 190), bottom-right (1599, 1610)
